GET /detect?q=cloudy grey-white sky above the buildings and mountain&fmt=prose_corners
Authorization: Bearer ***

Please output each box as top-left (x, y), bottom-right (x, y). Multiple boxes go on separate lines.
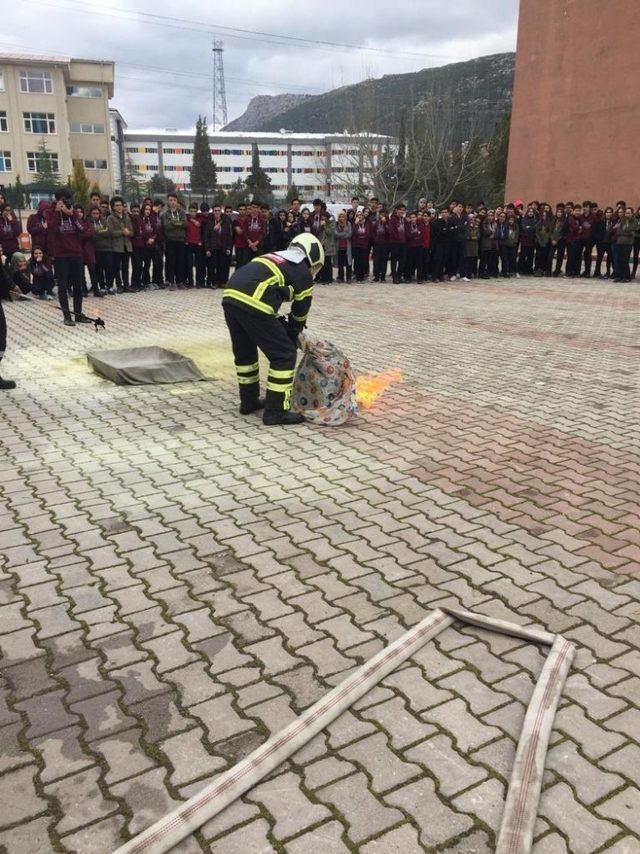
top-left (5, 0), bottom-right (518, 129)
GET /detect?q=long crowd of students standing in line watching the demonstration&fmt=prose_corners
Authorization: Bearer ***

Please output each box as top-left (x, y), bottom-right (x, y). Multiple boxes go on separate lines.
top-left (0, 188), bottom-right (640, 325)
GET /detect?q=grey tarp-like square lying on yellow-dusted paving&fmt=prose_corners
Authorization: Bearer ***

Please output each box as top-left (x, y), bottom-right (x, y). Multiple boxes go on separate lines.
top-left (87, 347), bottom-right (206, 385)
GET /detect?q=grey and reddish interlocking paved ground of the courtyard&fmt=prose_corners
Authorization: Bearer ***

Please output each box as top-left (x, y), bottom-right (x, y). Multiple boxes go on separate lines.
top-left (0, 279), bottom-right (640, 854)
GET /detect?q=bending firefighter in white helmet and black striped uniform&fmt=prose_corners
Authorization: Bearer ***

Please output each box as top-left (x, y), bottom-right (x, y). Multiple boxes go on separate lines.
top-left (222, 233), bottom-right (324, 426)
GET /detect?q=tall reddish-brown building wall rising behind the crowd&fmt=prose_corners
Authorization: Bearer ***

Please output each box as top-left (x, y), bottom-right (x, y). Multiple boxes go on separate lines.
top-left (506, 0), bottom-right (640, 206)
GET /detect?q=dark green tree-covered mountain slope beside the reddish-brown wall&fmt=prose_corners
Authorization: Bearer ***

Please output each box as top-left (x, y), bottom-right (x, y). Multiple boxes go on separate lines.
top-left (254, 53), bottom-right (515, 141)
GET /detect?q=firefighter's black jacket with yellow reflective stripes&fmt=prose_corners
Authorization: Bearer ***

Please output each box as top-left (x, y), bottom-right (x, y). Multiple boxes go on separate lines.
top-left (222, 252), bottom-right (313, 330)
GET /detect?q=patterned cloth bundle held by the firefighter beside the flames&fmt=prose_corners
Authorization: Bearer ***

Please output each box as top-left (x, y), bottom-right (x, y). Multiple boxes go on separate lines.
top-left (291, 333), bottom-right (358, 427)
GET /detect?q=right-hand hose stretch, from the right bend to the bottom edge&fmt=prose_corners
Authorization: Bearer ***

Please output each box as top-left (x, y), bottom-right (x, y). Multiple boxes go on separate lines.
top-left (496, 635), bottom-right (576, 854)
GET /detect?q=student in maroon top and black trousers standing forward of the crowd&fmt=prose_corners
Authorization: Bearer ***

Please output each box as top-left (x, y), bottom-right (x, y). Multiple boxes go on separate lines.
top-left (48, 188), bottom-right (91, 326)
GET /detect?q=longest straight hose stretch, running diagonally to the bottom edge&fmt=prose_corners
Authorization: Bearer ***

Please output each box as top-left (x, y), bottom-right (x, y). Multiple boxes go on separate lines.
top-left (115, 610), bottom-right (456, 854)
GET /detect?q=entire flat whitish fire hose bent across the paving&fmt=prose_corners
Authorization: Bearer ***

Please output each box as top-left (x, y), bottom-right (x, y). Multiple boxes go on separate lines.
top-left (114, 608), bottom-right (575, 854)
